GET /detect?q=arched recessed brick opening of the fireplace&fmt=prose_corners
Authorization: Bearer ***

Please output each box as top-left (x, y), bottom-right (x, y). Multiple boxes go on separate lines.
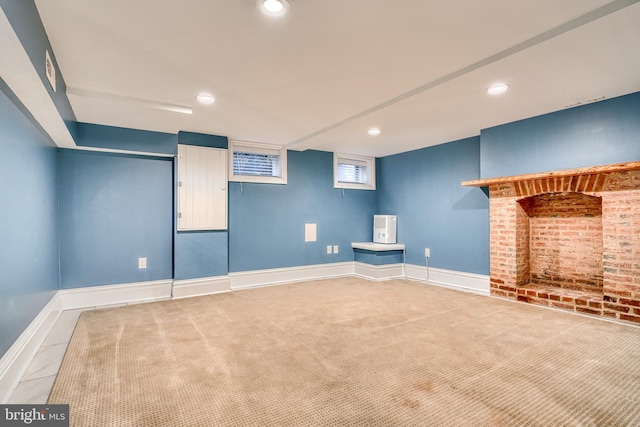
top-left (516, 192), bottom-right (603, 293)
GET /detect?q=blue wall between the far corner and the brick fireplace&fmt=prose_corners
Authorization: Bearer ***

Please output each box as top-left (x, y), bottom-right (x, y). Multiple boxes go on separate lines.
top-left (378, 137), bottom-right (489, 274)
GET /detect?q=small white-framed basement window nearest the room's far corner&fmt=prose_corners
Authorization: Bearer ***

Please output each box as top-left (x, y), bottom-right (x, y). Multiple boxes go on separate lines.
top-left (333, 153), bottom-right (376, 190)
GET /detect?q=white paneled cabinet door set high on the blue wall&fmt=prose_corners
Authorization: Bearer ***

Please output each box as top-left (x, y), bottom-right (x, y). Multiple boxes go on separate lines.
top-left (178, 144), bottom-right (227, 230)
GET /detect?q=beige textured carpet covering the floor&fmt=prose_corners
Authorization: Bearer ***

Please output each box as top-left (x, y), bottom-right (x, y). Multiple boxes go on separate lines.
top-left (49, 278), bottom-right (640, 426)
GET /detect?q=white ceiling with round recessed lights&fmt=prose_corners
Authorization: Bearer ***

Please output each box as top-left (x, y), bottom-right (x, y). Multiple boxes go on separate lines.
top-left (35, 0), bottom-right (640, 156)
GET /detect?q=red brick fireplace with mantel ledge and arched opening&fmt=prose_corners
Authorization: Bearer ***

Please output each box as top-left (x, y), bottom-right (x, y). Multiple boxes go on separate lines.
top-left (462, 162), bottom-right (640, 323)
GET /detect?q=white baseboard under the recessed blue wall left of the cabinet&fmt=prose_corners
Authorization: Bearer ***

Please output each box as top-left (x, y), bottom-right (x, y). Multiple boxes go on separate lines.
top-left (58, 279), bottom-right (173, 310)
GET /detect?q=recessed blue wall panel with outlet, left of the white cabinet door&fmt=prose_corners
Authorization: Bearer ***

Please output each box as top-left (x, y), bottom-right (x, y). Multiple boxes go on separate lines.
top-left (59, 150), bottom-right (173, 288)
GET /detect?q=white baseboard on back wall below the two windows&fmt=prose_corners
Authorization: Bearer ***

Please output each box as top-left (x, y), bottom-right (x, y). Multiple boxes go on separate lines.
top-left (229, 261), bottom-right (353, 290)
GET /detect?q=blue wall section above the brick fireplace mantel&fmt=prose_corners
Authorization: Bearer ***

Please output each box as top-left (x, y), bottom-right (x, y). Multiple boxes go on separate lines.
top-left (480, 92), bottom-right (640, 178)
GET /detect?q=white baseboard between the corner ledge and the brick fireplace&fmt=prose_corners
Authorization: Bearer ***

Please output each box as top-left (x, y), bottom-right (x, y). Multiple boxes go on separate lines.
top-left (405, 264), bottom-right (489, 295)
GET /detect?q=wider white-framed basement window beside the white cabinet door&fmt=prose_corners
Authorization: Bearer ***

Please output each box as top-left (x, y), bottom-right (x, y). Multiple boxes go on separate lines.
top-left (229, 141), bottom-right (287, 184)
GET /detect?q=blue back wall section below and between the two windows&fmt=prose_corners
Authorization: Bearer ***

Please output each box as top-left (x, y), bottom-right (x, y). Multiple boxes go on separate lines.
top-left (229, 150), bottom-right (378, 272)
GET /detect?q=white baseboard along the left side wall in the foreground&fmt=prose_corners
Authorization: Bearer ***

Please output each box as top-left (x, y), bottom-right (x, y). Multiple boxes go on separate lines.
top-left (0, 293), bottom-right (64, 404)
